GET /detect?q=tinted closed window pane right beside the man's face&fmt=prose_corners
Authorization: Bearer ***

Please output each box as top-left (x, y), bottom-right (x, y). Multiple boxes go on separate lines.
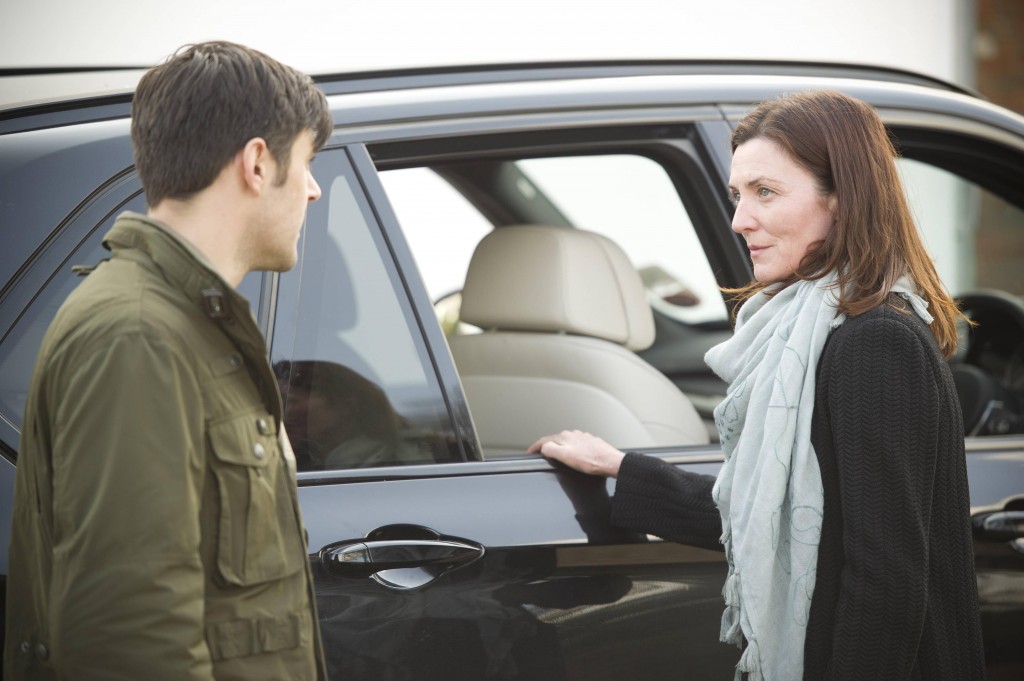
top-left (271, 151), bottom-right (461, 470)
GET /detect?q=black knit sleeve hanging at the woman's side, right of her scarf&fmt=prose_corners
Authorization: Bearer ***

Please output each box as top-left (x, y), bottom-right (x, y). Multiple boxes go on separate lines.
top-left (827, 318), bottom-right (939, 681)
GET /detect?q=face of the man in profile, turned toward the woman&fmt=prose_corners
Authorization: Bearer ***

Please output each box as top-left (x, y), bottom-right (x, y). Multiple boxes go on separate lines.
top-left (246, 130), bottom-right (321, 272)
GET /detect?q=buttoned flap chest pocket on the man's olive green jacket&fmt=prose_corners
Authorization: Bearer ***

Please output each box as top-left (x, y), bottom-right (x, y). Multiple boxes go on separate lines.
top-left (209, 413), bottom-right (306, 586)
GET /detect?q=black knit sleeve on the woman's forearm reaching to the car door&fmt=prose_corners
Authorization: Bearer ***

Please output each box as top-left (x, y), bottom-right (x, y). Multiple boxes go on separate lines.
top-left (611, 453), bottom-right (722, 551)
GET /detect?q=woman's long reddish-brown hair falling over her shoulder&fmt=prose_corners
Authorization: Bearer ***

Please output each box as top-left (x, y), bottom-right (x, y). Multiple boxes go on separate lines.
top-left (726, 90), bottom-right (962, 356)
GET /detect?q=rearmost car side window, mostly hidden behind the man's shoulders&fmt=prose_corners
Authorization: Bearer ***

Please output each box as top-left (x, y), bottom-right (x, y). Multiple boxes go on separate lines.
top-left (0, 194), bottom-right (262, 449)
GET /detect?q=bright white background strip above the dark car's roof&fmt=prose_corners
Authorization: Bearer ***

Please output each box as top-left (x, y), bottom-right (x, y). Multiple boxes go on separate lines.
top-left (0, 0), bottom-right (973, 85)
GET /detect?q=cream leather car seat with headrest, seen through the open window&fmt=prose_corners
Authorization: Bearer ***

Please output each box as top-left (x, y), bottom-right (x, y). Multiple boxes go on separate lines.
top-left (450, 225), bottom-right (709, 456)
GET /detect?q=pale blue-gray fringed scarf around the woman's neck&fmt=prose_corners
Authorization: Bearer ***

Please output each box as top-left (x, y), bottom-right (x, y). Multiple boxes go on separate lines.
top-left (705, 273), bottom-right (932, 681)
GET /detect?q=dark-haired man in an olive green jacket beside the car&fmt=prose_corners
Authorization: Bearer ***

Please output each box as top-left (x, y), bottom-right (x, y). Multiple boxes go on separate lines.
top-left (4, 42), bottom-right (332, 681)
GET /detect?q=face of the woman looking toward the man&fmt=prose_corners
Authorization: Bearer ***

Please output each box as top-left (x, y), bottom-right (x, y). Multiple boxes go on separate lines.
top-left (729, 137), bottom-right (836, 284)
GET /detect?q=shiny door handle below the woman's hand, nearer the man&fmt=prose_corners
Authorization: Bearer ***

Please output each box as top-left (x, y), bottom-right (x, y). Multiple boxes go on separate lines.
top-left (319, 540), bottom-right (483, 578)
